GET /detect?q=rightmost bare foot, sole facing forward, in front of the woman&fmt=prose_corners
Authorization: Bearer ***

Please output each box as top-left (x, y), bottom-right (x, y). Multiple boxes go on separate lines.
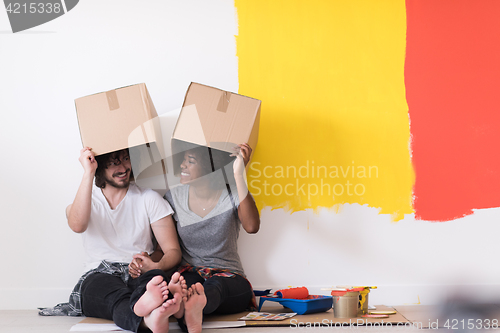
top-left (183, 282), bottom-right (207, 333)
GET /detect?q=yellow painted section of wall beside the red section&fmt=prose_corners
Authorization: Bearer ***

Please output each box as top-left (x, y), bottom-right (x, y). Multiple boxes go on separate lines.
top-left (235, 0), bottom-right (415, 221)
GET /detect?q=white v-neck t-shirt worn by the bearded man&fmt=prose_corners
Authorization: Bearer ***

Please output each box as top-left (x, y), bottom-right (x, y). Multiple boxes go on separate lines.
top-left (82, 183), bottom-right (174, 271)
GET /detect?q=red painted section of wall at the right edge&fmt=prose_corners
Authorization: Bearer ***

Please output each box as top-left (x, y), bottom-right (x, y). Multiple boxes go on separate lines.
top-left (405, 0), bottom-right (500, 221)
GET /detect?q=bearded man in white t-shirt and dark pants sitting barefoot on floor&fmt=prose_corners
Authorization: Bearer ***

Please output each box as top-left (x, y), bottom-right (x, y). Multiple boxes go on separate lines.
top-left (40, 147), bottom-right (187, 332)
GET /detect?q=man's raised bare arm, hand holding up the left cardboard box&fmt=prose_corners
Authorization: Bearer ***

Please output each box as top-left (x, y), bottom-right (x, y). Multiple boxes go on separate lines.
top-left (66, 147), bottom-right (97, 233)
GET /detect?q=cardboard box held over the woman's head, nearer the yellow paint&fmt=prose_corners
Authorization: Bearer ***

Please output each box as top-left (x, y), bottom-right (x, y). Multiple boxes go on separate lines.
top-left (171, 82), bottom-right (261, 173)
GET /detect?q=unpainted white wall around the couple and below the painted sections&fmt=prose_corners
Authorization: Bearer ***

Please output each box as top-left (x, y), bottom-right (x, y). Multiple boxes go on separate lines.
top-left (0, 0), bottom-right (500, 309)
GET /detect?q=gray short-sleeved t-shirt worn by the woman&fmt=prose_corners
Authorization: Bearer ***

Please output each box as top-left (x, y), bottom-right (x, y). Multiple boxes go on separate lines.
top-left (165, 185), bottom-right (245, 276)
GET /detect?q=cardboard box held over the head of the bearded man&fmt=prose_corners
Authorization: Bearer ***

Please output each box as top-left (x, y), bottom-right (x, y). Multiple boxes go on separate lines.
top-left (75, 83), bottom-right (166, 188)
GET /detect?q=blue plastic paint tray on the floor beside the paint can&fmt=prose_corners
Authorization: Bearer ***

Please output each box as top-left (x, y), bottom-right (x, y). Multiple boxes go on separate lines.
top-left (259, 295), bottom-right (333, 315)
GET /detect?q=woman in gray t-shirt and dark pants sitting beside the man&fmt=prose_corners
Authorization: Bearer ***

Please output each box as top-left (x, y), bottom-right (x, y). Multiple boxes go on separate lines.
top-left (165, 143), bottom-right (260, 331)
